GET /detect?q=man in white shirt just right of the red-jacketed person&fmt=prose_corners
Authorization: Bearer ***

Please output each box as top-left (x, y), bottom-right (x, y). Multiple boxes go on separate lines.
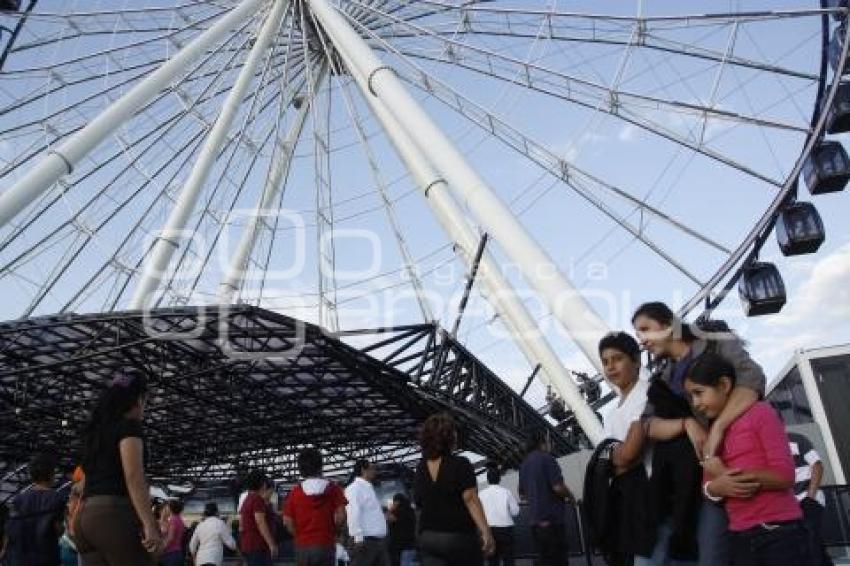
top-left (345, 460), bottom-right (390, 566)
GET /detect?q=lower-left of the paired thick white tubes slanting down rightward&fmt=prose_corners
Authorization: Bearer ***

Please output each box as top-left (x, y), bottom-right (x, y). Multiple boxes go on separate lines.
top-left (354, 85), bottom-right (604, 445)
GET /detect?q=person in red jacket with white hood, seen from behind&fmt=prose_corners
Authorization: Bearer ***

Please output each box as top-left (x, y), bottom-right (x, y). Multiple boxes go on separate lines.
top-left (283, 448), bottom-right (348, 566)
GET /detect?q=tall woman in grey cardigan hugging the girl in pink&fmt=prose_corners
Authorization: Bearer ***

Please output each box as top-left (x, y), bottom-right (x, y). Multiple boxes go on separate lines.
top-left (632, 302), bottom-right (766, 566)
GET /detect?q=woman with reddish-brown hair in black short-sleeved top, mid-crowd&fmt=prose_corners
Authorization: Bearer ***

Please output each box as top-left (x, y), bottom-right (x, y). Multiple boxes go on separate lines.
top-left (413, 413), bottom-right (495, 566)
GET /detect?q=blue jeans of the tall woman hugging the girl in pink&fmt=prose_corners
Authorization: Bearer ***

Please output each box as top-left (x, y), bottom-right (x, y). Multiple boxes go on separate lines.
top-left (635, 501), bottom-right (730, 566)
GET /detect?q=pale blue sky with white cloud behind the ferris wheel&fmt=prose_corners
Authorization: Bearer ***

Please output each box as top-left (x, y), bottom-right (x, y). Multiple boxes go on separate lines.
top-left (0, 0), bottom-right (850, 412)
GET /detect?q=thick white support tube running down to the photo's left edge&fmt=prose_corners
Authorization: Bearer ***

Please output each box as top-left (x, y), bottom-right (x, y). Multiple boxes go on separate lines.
top-left (0, 0), bottom-right (266, 233)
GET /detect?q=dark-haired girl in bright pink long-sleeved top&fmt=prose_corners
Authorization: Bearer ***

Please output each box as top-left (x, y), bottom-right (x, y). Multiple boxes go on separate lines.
top-left (685, 352), bottom-right (811, 566)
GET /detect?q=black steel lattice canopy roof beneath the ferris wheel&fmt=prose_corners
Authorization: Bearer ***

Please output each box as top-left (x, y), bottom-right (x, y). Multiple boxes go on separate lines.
top-left (0, 306), bottom-right (575, 502)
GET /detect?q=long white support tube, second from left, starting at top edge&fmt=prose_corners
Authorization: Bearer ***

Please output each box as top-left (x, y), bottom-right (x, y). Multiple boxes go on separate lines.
top-left (130, 0), bottom-right (289, 309)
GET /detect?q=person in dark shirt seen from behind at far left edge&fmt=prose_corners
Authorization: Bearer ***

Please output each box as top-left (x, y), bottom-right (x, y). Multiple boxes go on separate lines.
top-left (6, 454), bottom-right (65, 566)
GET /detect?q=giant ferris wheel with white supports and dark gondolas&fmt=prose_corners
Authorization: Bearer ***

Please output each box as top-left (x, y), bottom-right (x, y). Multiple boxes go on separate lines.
top-left (0, 0), bottom-right (850, 444)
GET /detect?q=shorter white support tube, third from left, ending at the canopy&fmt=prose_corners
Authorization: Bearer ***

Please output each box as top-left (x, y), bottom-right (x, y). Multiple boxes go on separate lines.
top-left (218, 63), bottom-right (328, 304)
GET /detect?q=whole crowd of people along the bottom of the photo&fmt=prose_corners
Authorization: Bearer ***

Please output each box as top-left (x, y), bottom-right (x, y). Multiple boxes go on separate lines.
top-left (0, 303), bottom-right (830, 566)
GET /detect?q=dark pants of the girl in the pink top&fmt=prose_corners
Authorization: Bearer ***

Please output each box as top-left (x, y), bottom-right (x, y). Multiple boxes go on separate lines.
top-left (732, 521), bottom-right (812, 566)
